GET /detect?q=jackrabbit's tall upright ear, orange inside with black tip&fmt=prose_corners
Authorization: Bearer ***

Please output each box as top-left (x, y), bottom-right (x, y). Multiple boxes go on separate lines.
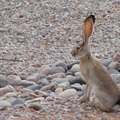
top-left (83, 15), bottom-right (95, 42)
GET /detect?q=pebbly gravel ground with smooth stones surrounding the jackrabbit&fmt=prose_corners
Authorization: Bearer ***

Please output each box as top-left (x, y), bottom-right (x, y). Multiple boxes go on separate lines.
top-left (0, 0), bottom-right (120, 120)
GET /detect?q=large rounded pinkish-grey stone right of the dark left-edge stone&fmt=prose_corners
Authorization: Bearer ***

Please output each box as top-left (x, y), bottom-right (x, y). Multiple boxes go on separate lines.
top-left (7, 75), bottom-right (22, 85)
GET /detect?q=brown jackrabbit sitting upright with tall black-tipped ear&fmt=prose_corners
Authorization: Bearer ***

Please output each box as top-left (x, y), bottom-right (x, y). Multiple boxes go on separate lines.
top-left (71, 15), bottom-right (120, 111)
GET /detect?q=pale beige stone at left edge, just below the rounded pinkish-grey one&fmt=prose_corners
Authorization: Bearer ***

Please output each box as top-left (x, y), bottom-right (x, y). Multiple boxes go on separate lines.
top-left (0, 85), bottom-right (16, 96)
